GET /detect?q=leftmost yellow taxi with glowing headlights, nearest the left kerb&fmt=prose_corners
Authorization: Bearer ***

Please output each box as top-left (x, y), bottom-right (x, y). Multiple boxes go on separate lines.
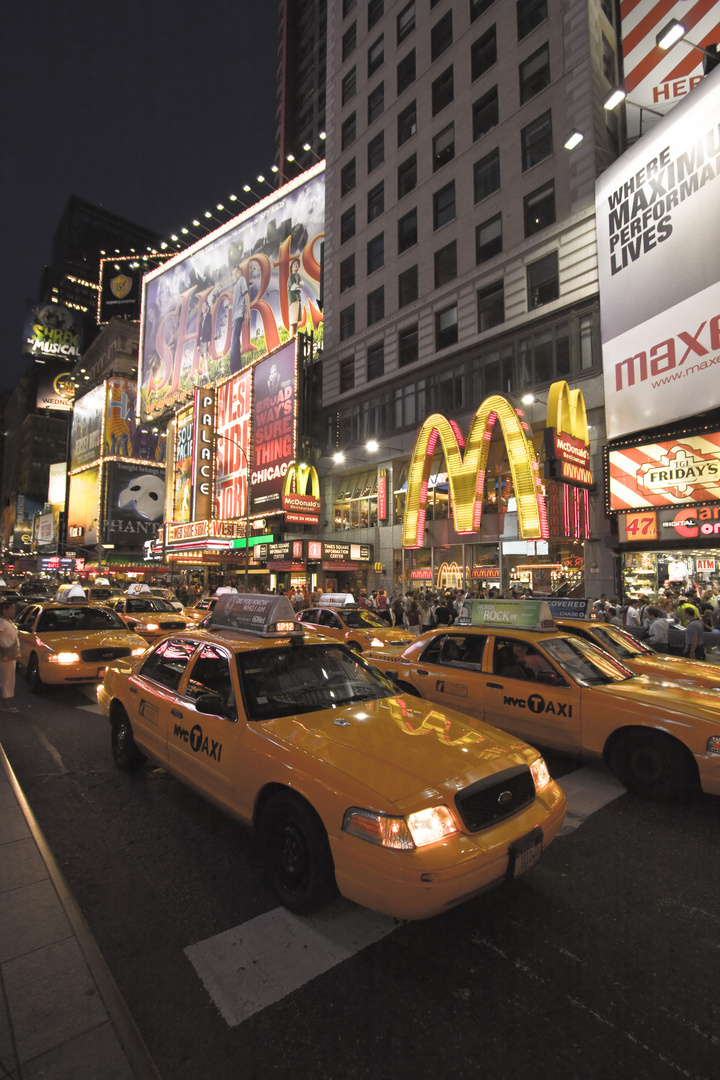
top-left (17, 584), bottom-right (148, 693)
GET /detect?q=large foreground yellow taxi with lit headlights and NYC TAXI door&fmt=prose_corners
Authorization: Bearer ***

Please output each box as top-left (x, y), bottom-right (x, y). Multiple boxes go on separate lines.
top-left (97, 594), bottom-right (566, 919)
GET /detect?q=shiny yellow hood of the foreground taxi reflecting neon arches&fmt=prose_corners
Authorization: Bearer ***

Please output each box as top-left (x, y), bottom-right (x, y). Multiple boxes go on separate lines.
top-left (258, 696), bottom-right (535, 809)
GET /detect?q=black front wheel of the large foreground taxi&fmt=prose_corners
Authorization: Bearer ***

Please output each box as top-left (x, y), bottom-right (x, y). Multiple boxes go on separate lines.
top-left (258, 792), bottom-right (337, 915)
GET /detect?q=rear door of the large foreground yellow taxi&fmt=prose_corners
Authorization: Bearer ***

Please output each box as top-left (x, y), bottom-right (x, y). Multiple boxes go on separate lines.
top-left (127, 637), bottom-right (196, 764)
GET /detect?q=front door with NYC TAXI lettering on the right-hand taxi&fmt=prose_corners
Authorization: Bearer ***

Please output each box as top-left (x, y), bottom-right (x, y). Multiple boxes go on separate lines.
top-left (485, 635), bottom-right (581, 753)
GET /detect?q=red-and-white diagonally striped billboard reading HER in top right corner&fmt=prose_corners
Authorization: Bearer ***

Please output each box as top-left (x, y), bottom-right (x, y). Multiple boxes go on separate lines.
top-left (621, 0), bottom-right (720, 139)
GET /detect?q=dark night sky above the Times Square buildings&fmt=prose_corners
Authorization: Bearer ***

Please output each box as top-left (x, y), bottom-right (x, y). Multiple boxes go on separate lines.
top-left (0, 0), bottom-right (277, 390)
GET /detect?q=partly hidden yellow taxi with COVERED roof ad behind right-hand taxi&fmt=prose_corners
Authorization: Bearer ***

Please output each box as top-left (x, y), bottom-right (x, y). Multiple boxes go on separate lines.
top-left (547, 597), bottom-right (720, 693)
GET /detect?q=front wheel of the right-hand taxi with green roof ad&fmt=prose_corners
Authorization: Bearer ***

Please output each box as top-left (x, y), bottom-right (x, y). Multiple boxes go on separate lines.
top-left (611, 729), bottom-right (697, 802)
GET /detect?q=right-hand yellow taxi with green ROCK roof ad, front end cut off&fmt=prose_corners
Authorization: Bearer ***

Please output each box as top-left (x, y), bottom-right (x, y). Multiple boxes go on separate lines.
top-left (367, 599), bottom-right (720, 801)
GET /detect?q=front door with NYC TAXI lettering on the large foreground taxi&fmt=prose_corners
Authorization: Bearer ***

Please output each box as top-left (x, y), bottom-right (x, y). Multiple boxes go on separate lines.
top-left (167, 642), bottom-right (244, 808)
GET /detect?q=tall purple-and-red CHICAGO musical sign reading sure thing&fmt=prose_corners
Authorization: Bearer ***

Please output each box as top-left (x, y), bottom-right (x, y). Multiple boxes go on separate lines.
top-left (250, 341), bottom-right (297, 514)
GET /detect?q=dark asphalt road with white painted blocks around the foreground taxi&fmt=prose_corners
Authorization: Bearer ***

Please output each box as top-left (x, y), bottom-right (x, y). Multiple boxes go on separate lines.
top-left (0, 683), bottom-right (720, 1080)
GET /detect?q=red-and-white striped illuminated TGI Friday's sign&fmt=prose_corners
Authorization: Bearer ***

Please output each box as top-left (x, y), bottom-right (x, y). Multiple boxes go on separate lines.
top-left (606, 431), bottom-right (720, 514)
